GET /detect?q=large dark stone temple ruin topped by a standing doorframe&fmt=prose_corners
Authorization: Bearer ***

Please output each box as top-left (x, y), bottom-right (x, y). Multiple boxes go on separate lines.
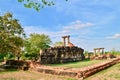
top-left (41, 36), bottom-right (85, 64)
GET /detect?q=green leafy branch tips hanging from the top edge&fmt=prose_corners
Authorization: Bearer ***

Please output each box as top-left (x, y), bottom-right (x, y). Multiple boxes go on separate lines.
top-left (18, 0), bottom-right (68, 11)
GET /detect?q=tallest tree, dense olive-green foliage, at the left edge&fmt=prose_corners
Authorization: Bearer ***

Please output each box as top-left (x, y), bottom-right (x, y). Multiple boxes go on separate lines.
top-left (0, 13), bottom-right (25, 59)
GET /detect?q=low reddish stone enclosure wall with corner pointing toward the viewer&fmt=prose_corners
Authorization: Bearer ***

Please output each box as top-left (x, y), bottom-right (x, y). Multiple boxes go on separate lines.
top-left (30, 58), bottom-right (120, 79)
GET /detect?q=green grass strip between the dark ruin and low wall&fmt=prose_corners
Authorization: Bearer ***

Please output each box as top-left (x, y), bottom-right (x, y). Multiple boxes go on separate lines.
top-left (45, 59), bottom-right (108, 68)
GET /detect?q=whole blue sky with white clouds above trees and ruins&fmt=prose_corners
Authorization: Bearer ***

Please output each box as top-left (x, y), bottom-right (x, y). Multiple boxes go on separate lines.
top-left (0, 0), bottom-right (120, 51)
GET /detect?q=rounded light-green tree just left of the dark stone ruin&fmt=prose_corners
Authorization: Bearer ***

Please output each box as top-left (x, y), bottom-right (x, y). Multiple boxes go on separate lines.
top-left (25, 33), bottom-right (51, 59)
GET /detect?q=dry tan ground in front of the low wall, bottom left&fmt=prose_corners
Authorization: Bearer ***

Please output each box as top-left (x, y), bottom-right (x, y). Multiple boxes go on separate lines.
top-left (0, 71), bottom-right (76, 80)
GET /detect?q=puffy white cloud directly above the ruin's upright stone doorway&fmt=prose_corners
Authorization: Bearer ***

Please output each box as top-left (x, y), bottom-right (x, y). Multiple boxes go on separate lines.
top-left (54, 20), bottom-right (94, 36)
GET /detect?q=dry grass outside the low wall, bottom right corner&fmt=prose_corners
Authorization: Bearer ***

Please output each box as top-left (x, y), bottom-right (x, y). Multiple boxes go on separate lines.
top-left (85, 63), bottom-right (120, 80)
